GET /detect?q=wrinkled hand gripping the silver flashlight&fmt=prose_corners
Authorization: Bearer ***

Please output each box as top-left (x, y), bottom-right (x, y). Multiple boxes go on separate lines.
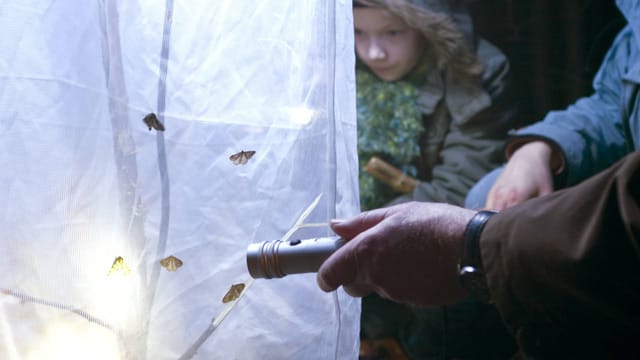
top-left (318, 202), bottom-right (475, 305)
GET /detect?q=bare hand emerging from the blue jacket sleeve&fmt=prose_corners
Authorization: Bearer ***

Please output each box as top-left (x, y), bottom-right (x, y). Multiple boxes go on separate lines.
top-left (485, 141), bottom-right (553, 211)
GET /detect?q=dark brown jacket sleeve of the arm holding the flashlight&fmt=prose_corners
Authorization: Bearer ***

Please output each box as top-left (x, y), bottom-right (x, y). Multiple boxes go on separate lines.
top-left (480, 152), bottom-right (640, 358)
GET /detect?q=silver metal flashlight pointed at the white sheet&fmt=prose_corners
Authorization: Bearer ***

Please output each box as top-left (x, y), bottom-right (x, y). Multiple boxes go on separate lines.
top-left (247, 236), bottom-right (345, 279)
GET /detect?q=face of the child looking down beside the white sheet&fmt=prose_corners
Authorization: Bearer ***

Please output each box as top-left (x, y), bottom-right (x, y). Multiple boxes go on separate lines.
top-left (353, 8), bottom-right (425, 81)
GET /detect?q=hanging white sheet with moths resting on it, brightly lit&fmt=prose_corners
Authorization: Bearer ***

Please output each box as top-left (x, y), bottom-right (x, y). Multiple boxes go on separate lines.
top-left (0, 0), bottom-right (360, 360)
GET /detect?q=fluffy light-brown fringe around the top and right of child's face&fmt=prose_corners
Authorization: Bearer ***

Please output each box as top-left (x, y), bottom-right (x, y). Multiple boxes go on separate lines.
top-left (353, 0), bottom-right (483, 77)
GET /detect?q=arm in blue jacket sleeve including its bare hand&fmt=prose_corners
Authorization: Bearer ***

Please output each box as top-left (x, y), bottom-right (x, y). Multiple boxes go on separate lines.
top-left (486, 28), bottom-right (640, 210)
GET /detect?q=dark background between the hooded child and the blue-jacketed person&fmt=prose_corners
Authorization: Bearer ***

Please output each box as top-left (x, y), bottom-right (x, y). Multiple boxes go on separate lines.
top-left (470, 0), bottom-right (626, 125)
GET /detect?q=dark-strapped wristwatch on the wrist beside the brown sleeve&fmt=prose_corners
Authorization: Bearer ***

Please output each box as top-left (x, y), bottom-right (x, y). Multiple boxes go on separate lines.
top-left (458, 210), bottom-right (496, 303)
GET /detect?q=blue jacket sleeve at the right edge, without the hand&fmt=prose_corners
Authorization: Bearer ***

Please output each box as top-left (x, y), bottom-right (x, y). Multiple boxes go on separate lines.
top-left (511, 27), bottom-right (638, 186)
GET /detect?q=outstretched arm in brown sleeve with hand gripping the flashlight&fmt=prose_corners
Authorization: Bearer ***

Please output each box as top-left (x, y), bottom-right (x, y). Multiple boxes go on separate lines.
top-left (318, 152), bottom-right (640, 357)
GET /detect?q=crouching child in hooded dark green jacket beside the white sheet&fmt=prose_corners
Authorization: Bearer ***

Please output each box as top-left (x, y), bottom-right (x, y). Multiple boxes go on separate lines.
top-left (354, 0), bottom-right (514, 210)
